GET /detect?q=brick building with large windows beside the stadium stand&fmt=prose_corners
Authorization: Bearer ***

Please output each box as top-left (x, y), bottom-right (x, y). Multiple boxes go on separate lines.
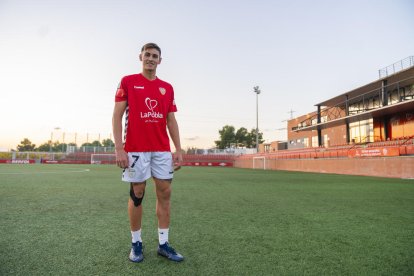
top-left (287, 56), bottom-right (414, 149)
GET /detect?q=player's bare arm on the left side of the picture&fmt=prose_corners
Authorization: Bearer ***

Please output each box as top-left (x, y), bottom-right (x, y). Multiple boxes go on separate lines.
top-left (112, 101), bottom-right (128, 168)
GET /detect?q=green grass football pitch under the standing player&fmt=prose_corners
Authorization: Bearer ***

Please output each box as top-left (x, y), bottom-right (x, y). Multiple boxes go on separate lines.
top-left (0, 165), bottom-right (414, 275)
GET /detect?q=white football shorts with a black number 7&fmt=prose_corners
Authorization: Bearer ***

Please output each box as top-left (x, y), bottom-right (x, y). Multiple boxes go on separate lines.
top-left (122, 152), bottom-right (174, 182)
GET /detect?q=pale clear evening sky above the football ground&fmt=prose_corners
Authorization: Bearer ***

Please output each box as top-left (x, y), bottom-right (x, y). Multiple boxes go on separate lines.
top-left (0, 0), bottom-right (414, 150)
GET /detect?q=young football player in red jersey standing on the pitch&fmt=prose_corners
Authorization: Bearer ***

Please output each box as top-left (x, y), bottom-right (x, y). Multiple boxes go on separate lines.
top-left (112, 43), bottom-right (184, 262)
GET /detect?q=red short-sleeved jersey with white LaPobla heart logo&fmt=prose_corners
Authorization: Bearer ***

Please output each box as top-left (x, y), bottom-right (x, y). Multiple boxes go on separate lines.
top-left (115, 74), bottom-right (177, 152)
